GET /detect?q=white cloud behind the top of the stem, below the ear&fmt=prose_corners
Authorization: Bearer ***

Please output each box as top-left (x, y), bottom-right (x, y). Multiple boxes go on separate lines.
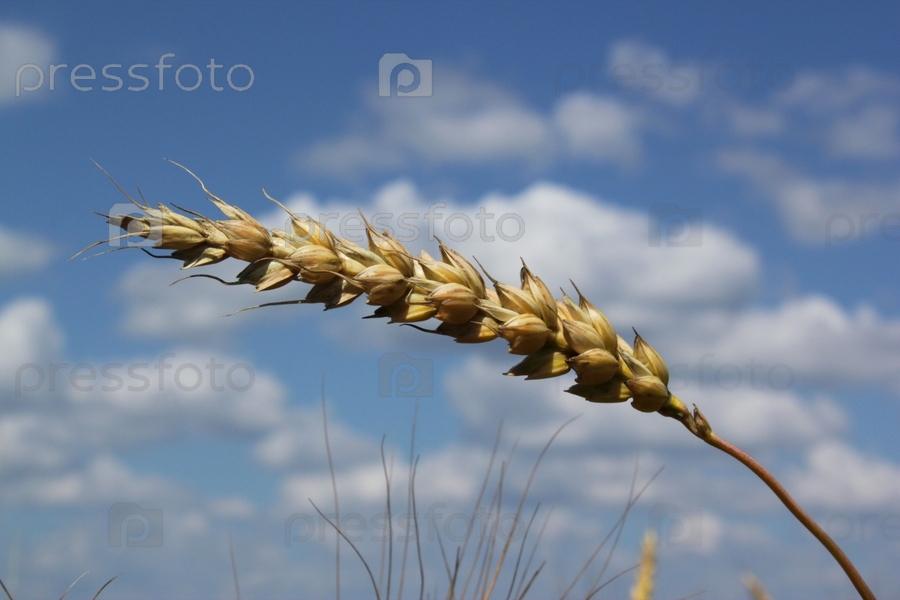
top-left (447, 356), bottom-right (847, 449)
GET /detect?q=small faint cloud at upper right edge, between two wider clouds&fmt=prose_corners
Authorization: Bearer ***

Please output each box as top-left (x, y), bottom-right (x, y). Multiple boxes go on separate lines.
top-left (827, 106), bottom-right (900, 159)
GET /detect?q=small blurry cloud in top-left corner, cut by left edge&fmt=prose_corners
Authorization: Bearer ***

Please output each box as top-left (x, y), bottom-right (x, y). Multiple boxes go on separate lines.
top-left (0, 23), bottom-right (54, 106)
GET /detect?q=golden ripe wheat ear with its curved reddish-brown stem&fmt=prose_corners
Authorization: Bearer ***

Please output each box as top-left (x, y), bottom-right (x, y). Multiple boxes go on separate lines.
top-left (76, 161), bottom-right (875, 600)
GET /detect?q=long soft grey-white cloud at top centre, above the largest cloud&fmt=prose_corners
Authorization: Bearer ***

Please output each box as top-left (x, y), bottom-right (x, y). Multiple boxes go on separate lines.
top-left (298, 71), bottom-right (645, 177)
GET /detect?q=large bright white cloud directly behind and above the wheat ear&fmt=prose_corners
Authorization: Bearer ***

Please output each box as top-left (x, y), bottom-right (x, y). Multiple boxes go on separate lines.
top-left (264, 180), bottom-right (759, 338)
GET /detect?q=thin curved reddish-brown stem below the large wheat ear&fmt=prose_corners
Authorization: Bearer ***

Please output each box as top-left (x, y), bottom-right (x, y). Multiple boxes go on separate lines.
top-left (659, 396), bottom-right (876, 600)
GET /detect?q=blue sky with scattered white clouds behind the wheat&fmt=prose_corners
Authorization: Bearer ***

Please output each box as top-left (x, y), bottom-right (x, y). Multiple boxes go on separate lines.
top-left (0, 1), bottom-right (900, 599)
